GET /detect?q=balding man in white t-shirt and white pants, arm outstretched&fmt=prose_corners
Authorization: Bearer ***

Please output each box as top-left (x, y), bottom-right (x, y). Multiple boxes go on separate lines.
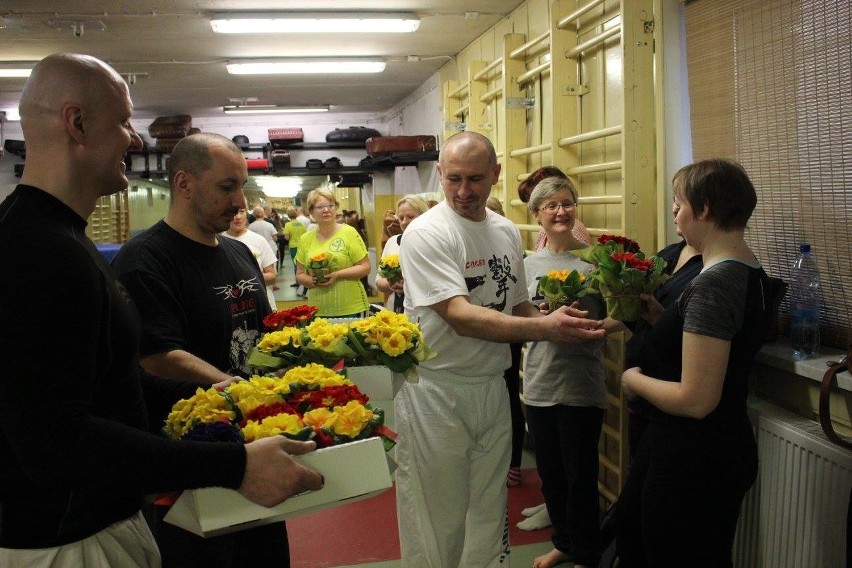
top-left (395, 132), bottom-right (605, 568)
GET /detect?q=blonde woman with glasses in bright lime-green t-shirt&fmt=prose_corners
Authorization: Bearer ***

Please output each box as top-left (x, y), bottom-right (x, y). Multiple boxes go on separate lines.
top-left (296, 188), bottom-right (370, 317)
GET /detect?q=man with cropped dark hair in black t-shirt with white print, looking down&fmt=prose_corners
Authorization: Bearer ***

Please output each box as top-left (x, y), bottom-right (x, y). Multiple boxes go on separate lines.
top-left (113, 133), bottom-right (300, 568)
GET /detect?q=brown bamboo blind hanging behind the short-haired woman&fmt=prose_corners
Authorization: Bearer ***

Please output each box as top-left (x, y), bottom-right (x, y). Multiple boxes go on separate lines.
top-left (686, 0), bottom-right (852, 348)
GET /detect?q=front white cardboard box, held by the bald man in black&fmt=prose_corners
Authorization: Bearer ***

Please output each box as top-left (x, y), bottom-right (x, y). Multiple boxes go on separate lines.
top-left (165, 438), bottom-right (395, 537)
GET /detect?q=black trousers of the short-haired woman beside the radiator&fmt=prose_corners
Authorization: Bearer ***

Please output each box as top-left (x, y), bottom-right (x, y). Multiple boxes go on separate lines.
top-left (616, 417), bottom-right (757, 568)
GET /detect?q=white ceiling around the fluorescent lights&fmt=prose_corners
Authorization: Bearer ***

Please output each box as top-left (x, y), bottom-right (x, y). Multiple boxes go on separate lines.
top-left (0, 0), bottom-right (524, 117)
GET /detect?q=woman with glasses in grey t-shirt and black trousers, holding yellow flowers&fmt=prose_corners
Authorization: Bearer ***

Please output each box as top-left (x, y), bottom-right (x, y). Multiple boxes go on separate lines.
top-left (523, 177), bottom-right (616, 568)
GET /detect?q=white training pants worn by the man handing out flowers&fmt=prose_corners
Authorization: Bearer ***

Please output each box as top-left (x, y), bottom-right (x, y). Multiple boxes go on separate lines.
top-left (394, 374), bottom-right (511, 568)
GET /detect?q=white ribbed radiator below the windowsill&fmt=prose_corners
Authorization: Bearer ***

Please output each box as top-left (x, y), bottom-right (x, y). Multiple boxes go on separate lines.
top-left (733, 399), bottom-right (852, 568)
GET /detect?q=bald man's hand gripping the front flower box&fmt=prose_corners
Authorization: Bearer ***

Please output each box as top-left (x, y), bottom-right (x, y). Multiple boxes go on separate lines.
top-left (238, 436), bottom-right (323, 507)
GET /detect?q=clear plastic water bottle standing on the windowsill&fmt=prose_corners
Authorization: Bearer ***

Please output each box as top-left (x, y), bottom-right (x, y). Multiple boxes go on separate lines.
top-left (790, 244), bottom-right (822, 359)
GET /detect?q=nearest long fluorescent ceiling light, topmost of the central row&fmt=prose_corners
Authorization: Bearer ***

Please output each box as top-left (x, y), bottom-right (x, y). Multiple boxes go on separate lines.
top-left (210, 12), bottom-right (420, 34)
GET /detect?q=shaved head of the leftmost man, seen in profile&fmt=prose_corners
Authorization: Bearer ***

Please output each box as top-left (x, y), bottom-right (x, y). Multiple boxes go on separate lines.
top-left (15, 53), bottom-right (142, 219)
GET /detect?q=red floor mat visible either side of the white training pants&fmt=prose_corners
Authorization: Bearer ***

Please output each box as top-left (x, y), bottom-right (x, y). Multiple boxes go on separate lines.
top-left (287, 468), bottom-right (550, 568)
